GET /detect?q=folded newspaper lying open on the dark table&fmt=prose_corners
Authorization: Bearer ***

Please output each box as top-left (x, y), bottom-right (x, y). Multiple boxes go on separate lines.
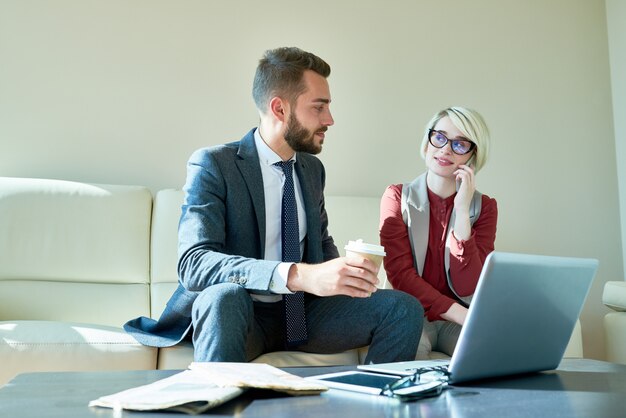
top-left (89, 362), bottom-right (328, 415)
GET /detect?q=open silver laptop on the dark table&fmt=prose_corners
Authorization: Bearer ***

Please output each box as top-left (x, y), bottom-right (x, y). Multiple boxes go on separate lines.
top-left (358, 252), bottom-right (598, 383)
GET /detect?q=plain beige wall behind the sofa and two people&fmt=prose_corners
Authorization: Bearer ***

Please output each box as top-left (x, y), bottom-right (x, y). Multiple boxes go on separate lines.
top-left (0, 0), bottom-right (624, 358)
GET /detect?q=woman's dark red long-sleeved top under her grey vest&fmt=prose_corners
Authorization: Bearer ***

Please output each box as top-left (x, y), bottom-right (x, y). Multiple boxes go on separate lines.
top-left (380, 184), bottom-right (498, 321)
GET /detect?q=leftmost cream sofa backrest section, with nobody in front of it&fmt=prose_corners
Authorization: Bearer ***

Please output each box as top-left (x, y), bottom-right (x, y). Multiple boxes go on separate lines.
top-left (0, 177), bottom-right (152, 326)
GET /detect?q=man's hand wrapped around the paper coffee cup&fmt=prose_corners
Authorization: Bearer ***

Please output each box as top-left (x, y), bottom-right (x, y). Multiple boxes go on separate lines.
top-left (287, 257), bottom-right (378, 298)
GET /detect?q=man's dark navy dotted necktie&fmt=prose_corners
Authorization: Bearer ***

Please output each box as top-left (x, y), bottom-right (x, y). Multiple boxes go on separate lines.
top-left (274, 160), bottom-right (307, 348)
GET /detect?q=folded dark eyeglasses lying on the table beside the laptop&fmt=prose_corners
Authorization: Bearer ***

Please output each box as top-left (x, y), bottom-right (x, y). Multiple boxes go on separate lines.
top-left (380, 367), bottom-right (450, 402)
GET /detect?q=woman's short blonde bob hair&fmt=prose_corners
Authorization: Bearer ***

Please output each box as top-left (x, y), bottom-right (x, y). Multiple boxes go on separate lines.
top-left (420, 106), bottom-right (489, 173)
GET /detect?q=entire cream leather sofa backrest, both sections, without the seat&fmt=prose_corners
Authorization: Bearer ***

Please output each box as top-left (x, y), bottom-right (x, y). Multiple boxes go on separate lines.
top-left (0, 177), bottom-right (386, 326)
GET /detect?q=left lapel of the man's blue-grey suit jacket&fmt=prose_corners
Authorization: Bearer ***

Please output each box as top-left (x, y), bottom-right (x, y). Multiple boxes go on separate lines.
top-left (235, 129), bottom-right (265, 254)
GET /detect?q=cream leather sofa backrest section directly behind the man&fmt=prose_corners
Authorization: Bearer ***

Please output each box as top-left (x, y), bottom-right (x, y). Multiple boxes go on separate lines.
top-left (150, 189), bottom-right (388, 319)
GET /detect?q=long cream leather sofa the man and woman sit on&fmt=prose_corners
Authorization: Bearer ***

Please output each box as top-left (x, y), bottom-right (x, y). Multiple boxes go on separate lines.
top-left (0, 177), bottom-right (582, 385)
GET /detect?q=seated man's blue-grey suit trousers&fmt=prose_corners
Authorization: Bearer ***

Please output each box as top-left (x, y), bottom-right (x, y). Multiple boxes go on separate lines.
top-left (192, 283), bottom-right (423, 364)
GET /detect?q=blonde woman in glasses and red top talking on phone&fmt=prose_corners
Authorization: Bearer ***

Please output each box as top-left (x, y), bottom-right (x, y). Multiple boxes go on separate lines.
top-left (380, 107), bottom-right (498, 357)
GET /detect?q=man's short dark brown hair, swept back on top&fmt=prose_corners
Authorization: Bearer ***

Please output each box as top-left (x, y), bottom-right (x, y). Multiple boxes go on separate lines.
top-left (252, 47), bottom-right (330, 111)
